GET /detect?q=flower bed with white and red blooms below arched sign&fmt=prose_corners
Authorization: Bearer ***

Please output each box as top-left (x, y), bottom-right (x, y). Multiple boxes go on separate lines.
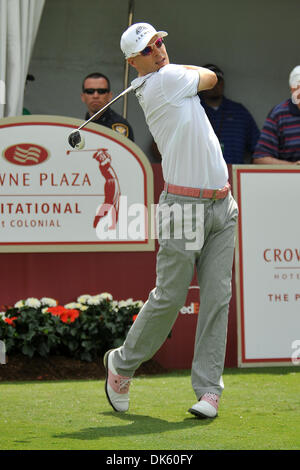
top-left (0, 293), bottom-right (143, 362)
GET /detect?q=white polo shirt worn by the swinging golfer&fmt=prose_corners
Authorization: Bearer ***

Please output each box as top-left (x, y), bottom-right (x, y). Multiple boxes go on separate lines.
top-left (132, 64), bottom-right (228, 189)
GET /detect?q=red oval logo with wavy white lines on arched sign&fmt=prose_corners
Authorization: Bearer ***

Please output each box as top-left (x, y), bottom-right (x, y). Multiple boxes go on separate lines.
top-left (3, 143), bottom-right (49, 166)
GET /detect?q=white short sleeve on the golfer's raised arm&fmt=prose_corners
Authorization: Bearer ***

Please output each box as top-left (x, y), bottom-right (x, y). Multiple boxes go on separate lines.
top-left (161, 64), bottom-right (199, 105)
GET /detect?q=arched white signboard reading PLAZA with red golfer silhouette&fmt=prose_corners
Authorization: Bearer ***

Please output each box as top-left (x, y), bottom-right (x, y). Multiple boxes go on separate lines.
top-left (0, 115), bottom-right (154, 252)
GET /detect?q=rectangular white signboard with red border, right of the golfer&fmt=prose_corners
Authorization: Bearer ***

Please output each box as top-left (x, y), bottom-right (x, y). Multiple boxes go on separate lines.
top-left (233, 165), bottom-right (300, 366)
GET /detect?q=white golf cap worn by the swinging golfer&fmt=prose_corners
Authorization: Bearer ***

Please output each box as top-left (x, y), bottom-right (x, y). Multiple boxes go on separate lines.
top-left (120, 23), bottom-right (168, 59)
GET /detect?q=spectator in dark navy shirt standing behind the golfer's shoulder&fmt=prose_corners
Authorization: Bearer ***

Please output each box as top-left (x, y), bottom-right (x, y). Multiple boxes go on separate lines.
top-left (198, 64), bottom-right (259, 164)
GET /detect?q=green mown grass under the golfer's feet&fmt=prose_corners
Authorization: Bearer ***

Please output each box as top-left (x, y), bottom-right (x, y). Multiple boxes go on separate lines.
top-left (0, 367), bottom-right (300, 450)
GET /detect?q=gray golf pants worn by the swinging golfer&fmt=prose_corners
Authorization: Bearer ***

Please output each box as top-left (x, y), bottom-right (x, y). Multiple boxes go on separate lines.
top-left (114, 191), bottom-right (238, 399)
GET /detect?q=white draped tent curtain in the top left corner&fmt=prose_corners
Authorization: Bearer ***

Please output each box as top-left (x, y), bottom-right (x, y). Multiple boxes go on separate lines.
top-left (0, 0), bottom-right (45, 118)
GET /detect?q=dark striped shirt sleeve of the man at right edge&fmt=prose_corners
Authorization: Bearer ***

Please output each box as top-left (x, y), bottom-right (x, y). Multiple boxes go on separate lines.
top-left (253, 107), bottom-right (279, 158)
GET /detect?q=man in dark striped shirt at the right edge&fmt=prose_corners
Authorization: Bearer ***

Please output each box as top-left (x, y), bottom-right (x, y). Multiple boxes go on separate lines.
top-left (253, 65), bottom-right (300, 165)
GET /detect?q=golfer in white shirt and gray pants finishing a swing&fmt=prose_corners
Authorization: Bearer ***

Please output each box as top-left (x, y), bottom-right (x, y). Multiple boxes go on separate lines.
top-left (104, 23), bottom-right (238, 418)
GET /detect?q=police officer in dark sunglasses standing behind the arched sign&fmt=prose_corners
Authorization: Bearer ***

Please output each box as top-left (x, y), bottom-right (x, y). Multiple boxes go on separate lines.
top-left (81, 72), bottom-right (134, 141)
